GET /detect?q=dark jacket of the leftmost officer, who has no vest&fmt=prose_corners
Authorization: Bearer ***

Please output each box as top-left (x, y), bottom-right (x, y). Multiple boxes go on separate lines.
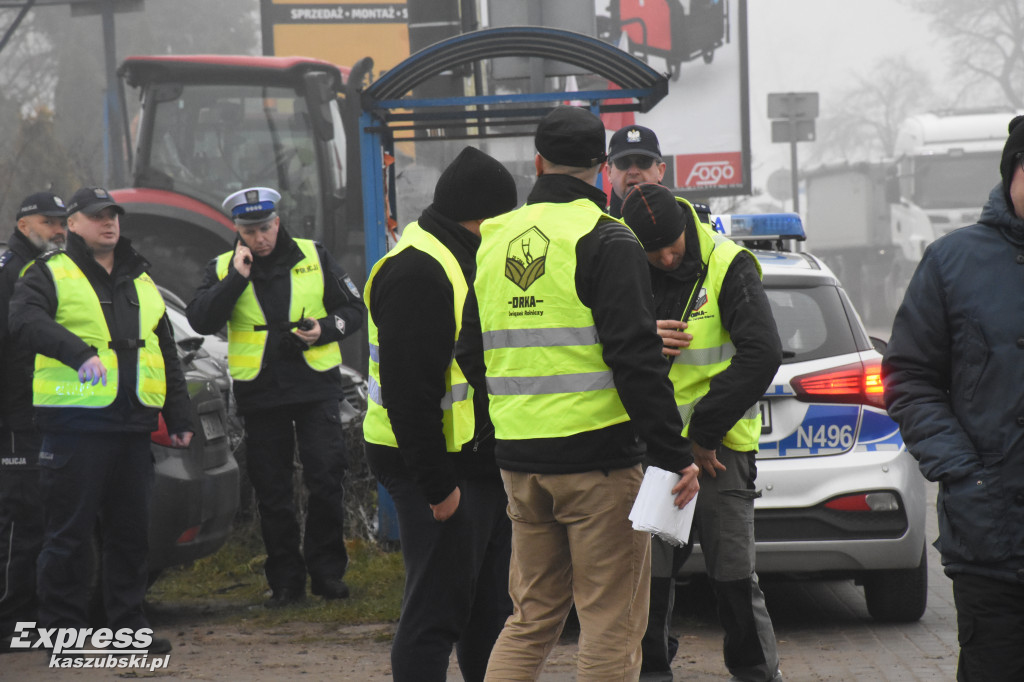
top-left (0, 229), bottom-right (42, 431)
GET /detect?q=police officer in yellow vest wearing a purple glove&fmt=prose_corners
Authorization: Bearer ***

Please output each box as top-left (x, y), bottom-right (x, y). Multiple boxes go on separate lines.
top-left (10, 187), bottom-right (193, 653)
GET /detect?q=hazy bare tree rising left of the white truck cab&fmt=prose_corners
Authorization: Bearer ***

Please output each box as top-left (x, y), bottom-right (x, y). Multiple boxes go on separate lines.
top-left (809, 56), bottom-right (933, 163)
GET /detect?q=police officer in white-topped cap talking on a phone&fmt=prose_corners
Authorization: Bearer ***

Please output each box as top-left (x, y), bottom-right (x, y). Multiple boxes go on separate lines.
top-left (186, 187), bottom-right (366, 607)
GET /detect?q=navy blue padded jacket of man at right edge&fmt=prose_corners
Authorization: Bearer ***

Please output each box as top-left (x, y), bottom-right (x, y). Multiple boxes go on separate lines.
top-left (882, 184), bottom-right (1024, 585)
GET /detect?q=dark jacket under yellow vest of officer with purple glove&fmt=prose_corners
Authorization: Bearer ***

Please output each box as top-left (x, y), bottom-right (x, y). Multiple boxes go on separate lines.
top-left (9, 228), bottom-right (193, 433)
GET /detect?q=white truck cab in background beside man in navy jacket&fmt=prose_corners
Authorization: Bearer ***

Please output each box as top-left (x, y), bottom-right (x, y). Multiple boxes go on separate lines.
top-left (894, 108), bottom-right (1022, 237)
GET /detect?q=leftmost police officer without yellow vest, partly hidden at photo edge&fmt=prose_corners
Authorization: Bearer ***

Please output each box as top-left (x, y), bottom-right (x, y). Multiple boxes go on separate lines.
top-left (0, 191), bottom-right (68, 653)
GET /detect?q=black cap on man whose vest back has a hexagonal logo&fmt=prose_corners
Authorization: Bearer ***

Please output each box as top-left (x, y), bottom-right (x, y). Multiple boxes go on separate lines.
top-left (534, 105), bottom-right (606, 168)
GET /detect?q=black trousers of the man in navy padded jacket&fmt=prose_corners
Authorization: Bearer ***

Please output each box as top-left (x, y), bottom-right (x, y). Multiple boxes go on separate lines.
top-left (952, 573), bottom-right (1024, 682)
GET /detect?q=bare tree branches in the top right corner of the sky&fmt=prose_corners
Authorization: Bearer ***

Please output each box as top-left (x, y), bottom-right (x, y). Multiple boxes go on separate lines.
top-left (903, 0), bottom-right (1024, 109)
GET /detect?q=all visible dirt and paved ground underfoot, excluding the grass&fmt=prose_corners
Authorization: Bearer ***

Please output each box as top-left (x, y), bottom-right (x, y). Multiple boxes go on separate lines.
top-left (0, 485), bottom-right (957, 682)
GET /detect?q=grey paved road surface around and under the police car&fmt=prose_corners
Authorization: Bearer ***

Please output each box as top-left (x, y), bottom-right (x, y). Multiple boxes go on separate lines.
top-left (528, 477), bottom-right (958, 682)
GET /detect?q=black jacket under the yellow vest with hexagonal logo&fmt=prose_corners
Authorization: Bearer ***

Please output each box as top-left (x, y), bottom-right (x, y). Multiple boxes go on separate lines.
top-left (457, 174), bottom-right (693, 473)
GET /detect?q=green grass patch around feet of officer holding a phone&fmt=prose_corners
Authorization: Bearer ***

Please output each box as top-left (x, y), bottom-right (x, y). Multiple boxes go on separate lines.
top-left (147, 532), bottom-right (404, 625)
